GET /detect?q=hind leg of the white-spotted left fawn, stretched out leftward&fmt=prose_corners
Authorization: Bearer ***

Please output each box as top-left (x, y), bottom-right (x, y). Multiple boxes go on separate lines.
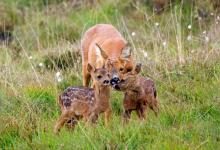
top-left (54, 111), bottom-right (73, 134)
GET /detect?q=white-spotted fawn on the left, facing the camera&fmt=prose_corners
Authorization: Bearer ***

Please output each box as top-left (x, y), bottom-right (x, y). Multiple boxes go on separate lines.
top-left (54, 64), bottom-right (111, 133)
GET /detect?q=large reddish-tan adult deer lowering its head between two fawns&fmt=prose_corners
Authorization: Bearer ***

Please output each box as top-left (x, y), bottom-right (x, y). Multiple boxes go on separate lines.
top-left (81, 24), bottom-right (133, 87)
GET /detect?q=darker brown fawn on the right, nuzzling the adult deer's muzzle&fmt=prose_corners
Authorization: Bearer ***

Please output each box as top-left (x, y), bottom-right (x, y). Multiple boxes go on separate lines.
top-left (114, 64), bottom-right (159, 122)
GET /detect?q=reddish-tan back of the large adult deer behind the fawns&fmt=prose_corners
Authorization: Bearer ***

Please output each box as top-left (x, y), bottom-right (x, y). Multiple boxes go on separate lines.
top-left (81, 24), bottom-right (127, 63)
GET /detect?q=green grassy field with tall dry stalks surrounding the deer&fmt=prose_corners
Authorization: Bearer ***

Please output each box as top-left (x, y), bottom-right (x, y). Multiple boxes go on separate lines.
top-left (0, 0), bottom-right (220, 150)
